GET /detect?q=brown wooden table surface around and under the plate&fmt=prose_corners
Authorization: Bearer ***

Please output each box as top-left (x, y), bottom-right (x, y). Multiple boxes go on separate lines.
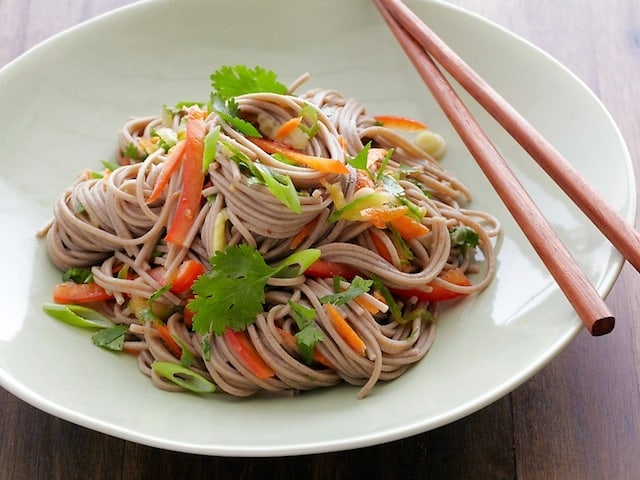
top-left (0, 0), bottom-right (640, 480)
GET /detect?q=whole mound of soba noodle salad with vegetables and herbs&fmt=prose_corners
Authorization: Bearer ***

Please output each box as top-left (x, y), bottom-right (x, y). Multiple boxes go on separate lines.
top-left (40, 65), bottom-right (500, 398)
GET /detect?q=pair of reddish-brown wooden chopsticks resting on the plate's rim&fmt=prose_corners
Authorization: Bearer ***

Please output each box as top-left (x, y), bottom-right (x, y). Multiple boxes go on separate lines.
top-left (373, 0), bottom-right (640, 336)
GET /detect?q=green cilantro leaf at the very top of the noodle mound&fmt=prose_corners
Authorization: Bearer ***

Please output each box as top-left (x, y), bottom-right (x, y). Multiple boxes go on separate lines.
top-left (211, 65), bottom-right (288, 100)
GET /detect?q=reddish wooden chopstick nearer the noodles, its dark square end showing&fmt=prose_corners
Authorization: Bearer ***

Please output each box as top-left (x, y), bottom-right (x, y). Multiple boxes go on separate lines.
top-left (373, 0), bottom-right (616, 336)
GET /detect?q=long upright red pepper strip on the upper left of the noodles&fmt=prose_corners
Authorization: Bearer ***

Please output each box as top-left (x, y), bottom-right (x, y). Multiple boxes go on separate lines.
top-left (166, 107), bottom-right (206, 247)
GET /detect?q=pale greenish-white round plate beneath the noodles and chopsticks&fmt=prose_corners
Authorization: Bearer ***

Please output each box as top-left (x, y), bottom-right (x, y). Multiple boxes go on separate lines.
top-left (0, 0), bottom-right (635, 456)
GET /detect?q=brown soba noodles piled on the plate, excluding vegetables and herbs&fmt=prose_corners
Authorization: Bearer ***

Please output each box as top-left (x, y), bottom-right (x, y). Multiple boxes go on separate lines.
top-left (42, 76), bottom-right (499, 397)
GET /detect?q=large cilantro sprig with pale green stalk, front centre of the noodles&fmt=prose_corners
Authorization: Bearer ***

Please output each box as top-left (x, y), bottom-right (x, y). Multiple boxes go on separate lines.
top-left (188, 244), bottom-right (320, 335)
